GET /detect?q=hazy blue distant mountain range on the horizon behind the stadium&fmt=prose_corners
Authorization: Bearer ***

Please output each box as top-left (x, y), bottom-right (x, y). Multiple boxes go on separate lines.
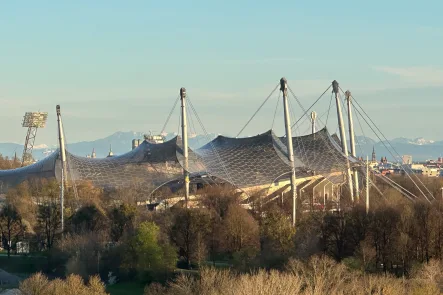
top-left (0, 132), bottom-right (443, 161)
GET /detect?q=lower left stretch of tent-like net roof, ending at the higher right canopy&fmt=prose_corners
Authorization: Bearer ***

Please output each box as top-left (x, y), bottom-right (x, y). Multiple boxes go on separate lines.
top-left (0, 137), bottom-right (204, 197)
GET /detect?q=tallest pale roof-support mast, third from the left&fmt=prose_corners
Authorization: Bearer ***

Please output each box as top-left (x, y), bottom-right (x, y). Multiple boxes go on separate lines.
top-left (280, 78), bottom-right (297, 226)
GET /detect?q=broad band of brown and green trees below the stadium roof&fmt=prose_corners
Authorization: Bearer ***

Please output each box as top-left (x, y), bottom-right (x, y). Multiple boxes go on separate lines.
top-left (0, 179), bottom-right (443, 292)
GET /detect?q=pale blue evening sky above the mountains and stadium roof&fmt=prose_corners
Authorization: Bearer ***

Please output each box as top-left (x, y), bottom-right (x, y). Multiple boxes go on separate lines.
top-left (0, 0), bottom-right (443, 144)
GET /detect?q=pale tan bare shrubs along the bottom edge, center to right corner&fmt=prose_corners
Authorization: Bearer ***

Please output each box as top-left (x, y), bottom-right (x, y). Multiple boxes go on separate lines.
top-left (145, 256), bottom-right (442, 295)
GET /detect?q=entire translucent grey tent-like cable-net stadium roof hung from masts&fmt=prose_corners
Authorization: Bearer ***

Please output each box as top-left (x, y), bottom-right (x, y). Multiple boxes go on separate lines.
top-left (0, 129), bottom-right (355, 197)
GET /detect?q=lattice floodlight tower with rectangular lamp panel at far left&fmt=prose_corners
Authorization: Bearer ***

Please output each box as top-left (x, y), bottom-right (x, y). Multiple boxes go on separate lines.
top-left (22, 112), bottom-right (48, 166)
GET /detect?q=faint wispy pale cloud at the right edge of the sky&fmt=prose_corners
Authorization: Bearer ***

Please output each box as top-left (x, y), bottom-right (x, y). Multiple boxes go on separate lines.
top-left (373, 66), bottom-right (443, 87)
